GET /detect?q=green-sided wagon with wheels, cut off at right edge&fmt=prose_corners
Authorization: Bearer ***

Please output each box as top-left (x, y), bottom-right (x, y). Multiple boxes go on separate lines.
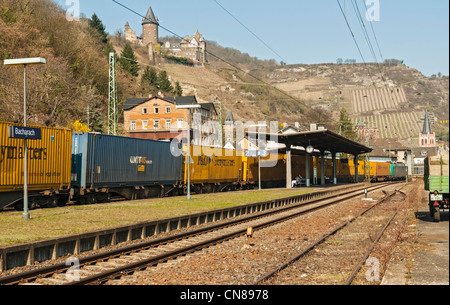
top-left (424, 156), bottom-right (449, 222)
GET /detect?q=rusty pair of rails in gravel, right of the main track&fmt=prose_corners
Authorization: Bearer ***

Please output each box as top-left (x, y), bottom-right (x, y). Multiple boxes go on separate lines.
top-left (254, 182), bottom-right (407, 285)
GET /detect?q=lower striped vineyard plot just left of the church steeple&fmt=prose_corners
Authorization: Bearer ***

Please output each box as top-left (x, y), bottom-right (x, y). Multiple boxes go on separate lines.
top-left (352, 112), bottom-right (423, 139)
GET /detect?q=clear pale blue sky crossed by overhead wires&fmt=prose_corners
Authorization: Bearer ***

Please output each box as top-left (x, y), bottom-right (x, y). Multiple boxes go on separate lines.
top-left (53, 0), bottom-right (449, 76)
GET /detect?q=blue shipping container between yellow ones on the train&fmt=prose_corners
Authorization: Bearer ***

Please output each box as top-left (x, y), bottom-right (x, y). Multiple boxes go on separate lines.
top-left (72, 133), bottom-right (182, 188)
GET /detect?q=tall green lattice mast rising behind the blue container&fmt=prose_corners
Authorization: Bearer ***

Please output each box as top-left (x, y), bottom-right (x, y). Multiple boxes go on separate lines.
top-left (108, 52), bottom-right (119, 135)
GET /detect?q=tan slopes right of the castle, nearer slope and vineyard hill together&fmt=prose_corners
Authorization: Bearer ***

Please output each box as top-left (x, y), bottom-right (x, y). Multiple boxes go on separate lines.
top-left (124, 34), bottom-right (449, 145)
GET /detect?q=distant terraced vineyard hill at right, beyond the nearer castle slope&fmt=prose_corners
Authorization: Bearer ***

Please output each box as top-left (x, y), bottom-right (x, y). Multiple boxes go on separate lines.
top-left (265, 64), bottom-right (449, 142)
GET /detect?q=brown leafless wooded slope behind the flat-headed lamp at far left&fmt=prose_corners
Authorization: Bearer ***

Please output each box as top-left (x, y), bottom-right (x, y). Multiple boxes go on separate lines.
top-left (0, 0), bottom-right (112, 128)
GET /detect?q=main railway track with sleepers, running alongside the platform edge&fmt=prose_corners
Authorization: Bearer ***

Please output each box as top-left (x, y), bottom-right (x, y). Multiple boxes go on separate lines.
top-left (0, 184), bottom-right (392, 285)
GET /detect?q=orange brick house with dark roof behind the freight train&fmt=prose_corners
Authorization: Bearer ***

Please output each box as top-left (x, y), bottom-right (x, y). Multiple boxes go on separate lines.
top-left (123, 96), bottom-right (217, 146)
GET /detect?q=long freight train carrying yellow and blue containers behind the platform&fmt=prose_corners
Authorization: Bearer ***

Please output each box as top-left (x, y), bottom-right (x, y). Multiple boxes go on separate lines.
top-left (0, 122), bottom-right (406, 210)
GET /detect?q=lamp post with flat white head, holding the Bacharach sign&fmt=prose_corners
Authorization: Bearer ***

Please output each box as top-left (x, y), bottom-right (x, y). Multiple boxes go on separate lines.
top-left (4, 57), bottom-right (47, 220)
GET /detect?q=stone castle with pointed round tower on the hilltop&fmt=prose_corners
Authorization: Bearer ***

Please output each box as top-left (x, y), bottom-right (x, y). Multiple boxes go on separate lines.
top-left (125, 6), bottom-right (208, 64)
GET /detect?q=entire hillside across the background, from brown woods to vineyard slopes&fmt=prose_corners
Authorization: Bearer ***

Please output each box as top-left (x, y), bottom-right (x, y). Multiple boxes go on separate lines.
top-left (0, 0), bottom-right (449, 146)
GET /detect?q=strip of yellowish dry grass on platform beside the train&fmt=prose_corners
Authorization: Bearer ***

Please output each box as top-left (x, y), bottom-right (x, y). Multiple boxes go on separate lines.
top-left (0, 189), bottom-right (314, 247)
